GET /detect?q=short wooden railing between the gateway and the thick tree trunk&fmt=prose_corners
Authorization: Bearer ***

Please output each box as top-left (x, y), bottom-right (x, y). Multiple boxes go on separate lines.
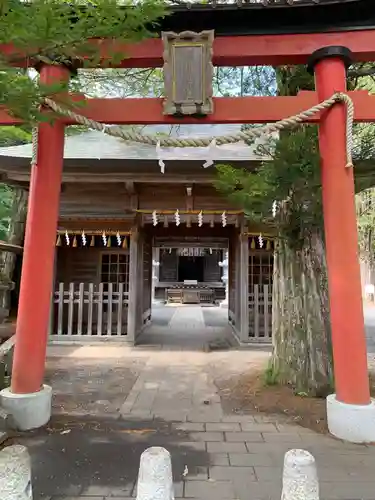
top-left (249, 285), bottom-right (272, 343)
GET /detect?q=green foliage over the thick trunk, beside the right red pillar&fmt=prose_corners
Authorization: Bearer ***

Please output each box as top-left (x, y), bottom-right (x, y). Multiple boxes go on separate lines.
top-left (215, 125), bottom-right (322, 245)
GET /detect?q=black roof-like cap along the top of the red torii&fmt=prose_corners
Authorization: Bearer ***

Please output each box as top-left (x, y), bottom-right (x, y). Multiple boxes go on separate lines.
top-left (156, 0), bottom-right (375, 36)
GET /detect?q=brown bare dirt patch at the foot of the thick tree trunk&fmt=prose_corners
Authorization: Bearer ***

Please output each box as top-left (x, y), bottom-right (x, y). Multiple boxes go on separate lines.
top-left (217, 369), bottom-right (375, 434)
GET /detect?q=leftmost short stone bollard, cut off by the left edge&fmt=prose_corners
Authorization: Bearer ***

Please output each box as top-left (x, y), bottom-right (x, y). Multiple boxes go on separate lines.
top-left (0, 445), bottom-right (33, 500)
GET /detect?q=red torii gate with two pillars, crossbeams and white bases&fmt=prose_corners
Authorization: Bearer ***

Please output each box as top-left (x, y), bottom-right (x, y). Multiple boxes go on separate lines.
top-left (0, 30), bottom-right (375, 442)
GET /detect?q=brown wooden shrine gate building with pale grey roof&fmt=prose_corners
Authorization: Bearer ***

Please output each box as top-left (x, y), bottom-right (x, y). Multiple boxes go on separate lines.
top-left (0, 125), bottom-right (273, 344)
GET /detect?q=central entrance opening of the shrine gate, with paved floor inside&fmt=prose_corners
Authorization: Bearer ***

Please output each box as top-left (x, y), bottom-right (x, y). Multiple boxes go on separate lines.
top-left (135, 226), bottom-right (238, 350)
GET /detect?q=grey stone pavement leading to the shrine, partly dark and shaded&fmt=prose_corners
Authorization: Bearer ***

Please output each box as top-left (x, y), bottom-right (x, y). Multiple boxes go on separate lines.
top-left (7, 308), bottom-right (375, 500)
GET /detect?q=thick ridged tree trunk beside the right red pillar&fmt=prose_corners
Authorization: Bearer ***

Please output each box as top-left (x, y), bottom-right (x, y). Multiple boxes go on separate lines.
top-left (271, 232), bottom-right (333, 397)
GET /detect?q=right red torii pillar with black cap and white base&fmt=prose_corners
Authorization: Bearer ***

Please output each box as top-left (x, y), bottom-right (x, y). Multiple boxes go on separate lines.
top-left (309, 46), bottom-right (375, 443)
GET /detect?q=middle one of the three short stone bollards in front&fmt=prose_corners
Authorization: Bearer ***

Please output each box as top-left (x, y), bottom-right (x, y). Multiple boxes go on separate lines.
top-left (137, 446), bottom-right (174, 500)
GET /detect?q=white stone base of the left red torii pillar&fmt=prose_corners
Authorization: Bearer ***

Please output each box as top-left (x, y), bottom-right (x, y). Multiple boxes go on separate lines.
top-left (0, 385), bottom-right (52, 431)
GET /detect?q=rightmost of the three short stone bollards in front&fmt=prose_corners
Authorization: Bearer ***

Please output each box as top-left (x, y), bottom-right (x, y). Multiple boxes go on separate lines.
top-left (281, 450), bottom-right (319, 500)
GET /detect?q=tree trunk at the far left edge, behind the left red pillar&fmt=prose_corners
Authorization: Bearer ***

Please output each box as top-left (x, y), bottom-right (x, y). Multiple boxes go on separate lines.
top-left (1, 189), bottom-right (28, 310)
